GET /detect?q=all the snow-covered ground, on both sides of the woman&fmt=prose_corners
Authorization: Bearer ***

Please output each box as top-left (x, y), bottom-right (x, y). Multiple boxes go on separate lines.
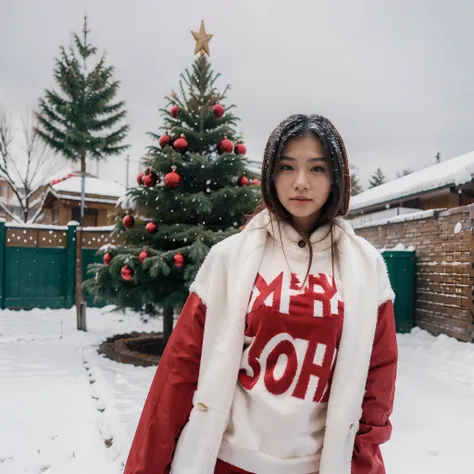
top-left (0, 308), bottom-right (474, 474)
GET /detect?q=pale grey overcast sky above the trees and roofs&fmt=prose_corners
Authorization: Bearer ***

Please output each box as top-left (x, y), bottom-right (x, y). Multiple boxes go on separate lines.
top-left (0, 0), bottom-right (474, 189)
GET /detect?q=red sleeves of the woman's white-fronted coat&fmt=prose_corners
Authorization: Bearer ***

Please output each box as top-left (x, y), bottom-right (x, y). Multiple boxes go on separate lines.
top-left (124, 293), bottom-right (398, 474)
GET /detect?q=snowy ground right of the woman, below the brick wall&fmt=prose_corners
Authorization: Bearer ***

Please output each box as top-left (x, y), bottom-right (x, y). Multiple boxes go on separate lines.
top-left (382, 328), bottom-right (474, 474)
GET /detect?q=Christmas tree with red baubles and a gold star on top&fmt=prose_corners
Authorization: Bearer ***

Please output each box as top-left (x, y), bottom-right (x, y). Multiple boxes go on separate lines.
top-left (84, 24), bottom-right (261, 341)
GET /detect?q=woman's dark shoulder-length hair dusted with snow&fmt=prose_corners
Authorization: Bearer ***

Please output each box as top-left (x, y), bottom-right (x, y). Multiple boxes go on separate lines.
top-left (246, 114), bottom-right (351, 285)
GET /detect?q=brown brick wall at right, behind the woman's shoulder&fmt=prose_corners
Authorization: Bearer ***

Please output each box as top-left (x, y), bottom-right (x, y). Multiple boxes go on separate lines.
top-left (355, 204), bottom-right (474, 341)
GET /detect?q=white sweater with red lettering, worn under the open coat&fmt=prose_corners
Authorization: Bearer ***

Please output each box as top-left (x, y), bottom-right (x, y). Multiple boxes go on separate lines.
top-left (219, 220), bottom-right (344, 474)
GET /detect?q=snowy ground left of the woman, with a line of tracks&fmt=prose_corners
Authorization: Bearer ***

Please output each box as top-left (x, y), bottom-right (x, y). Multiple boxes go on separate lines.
top-left (0, 307), bottom-right (161, 474)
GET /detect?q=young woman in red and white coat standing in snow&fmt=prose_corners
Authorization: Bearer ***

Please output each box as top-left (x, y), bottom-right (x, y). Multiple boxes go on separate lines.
top-left (125, 115), bottom-right (398, 474)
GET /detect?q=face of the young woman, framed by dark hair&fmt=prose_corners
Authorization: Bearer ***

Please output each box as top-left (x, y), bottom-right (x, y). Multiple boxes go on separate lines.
top-left (275, 135), bottom-right (332, 232)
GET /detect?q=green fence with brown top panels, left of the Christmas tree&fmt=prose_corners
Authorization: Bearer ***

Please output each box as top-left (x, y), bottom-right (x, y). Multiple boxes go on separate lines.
top-left (0, 220), bottom-right (114, 310)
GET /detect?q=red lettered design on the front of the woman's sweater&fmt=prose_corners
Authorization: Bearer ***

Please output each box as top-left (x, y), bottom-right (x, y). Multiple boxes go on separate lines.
top-left (239, 273), bottom-right (343, 402)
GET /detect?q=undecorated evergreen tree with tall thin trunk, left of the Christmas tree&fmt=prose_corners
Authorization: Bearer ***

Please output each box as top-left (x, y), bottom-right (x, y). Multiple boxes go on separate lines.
top-left (35, 18), bottom-right (129, 225)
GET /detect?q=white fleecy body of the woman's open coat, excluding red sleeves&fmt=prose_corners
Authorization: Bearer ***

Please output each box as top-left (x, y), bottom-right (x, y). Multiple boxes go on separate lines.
top-left (171, 211), bottom-right (394, 474)
